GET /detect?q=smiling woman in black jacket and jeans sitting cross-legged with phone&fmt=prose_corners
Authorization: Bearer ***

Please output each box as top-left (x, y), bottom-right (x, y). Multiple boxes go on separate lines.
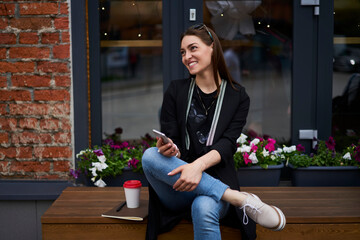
top-left (142, 24), bottom-right (285, 240)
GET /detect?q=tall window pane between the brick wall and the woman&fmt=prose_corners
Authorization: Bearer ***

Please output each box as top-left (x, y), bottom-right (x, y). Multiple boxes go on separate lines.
top-left (99, 0), bottom-right (163, 140)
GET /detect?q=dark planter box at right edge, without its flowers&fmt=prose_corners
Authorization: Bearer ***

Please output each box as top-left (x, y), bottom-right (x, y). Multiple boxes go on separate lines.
top-left (289, 165), bottom-right (360, 187)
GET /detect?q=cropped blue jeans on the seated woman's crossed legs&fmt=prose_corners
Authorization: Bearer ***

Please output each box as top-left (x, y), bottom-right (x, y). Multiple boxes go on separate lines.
top-left (142, 147), bottom-right (229, 240)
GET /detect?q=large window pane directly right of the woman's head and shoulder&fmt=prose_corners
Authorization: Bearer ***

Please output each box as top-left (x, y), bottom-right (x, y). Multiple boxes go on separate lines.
top-left (204, 0), bottom-right (293, 141)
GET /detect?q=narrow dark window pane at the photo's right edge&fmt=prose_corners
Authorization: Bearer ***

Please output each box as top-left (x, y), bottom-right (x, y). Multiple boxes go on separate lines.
top-left (332, 0), bottom-right (360, 149)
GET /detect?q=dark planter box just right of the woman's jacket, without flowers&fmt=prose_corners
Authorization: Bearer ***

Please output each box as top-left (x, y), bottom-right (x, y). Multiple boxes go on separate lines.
top-left (237, 163), bottom-right (284, 187)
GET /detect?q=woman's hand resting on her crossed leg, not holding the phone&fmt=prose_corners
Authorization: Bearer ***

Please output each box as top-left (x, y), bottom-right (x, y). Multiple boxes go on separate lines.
top-left (168, 161), bottom-right (203, 192)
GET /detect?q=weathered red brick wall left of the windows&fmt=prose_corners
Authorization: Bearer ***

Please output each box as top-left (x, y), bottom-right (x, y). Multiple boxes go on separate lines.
top-left (0, 0), bottom-right (72, 179)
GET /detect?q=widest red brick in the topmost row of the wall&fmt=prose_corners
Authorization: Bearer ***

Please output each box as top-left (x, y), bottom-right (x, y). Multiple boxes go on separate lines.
top-left (19, 3), bottom-right (59, 15)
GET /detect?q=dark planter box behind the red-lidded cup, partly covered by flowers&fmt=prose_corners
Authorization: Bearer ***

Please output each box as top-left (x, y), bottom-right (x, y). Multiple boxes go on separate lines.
top-left (85, 168), bottom-right (149, 187)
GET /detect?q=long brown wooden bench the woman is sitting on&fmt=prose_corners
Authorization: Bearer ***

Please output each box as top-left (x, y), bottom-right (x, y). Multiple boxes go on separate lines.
top-left (41, 187), bottom-right (360, 240)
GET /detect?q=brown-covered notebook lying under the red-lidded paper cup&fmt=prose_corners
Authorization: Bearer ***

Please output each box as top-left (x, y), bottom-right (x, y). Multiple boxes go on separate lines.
top-left (101, 200), bottom-right (149, 221)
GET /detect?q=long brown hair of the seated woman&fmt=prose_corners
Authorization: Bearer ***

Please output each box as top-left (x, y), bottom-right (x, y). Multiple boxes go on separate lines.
top-left (180, 24), bottom-right (240, 95)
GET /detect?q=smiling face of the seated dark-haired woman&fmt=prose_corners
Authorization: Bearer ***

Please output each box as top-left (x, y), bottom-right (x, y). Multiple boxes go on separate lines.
top-left (180, 35), bottom-right (213, 75)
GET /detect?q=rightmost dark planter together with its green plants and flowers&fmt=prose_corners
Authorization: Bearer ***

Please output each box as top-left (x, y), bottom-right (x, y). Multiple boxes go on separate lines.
top-left (288, 137), bottom-right (360, 186)
